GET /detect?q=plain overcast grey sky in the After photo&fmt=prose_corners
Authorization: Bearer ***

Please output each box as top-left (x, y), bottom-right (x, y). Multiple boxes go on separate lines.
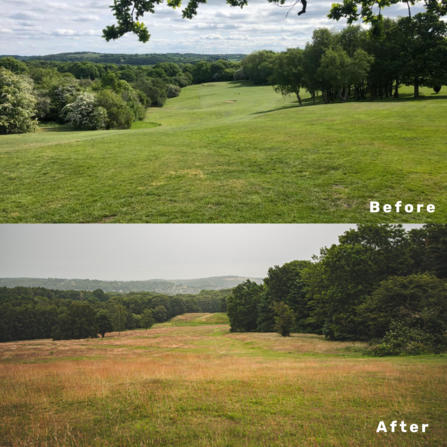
top-left (0, 224), bottom-right (420, 281)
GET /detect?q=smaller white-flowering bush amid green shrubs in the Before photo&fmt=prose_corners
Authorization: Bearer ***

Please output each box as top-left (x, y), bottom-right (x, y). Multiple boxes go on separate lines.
top-left (62, 92), bottom-right (108, 129)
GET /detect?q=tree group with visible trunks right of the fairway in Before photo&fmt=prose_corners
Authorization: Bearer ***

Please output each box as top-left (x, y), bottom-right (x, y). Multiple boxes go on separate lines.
top-left (242, 18), bottom-right (447, 105)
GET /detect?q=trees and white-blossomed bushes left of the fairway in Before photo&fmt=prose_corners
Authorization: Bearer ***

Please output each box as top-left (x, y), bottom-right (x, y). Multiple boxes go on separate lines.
top-left (0, 57), bottom-right (243, 134)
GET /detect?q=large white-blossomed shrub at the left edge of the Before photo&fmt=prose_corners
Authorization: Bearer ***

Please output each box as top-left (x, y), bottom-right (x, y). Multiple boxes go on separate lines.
top-left (0, 68), bottom-right (37, 134)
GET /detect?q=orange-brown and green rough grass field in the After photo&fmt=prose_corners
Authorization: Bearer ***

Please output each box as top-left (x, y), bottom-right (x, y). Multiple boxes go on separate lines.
top-left (0, 314), bottom-right (447, 447)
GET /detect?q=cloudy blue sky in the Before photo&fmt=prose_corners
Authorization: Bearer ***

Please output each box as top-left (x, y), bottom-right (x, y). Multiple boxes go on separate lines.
top-left (0, 0), bottom-right (420, 55)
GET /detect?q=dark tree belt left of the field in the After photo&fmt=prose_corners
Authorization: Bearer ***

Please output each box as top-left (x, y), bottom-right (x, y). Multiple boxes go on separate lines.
top-left (0, 287), bottom-right (231, 341)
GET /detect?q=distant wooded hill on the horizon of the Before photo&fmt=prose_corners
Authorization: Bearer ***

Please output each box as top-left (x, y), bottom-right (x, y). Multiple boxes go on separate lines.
top-left (0, 51), bottom-right (246, 65)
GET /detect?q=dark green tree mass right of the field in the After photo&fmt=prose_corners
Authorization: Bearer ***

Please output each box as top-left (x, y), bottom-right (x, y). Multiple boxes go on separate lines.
top-left (227, 224), bottom-right (447, 353)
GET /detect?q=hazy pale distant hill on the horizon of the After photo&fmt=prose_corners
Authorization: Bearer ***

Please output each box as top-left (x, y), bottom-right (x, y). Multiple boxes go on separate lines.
top-left (0, 276), bottom-right (263, 295)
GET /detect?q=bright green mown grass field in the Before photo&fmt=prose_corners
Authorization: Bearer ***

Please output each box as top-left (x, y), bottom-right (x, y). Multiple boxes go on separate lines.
top-left (0, 82), bottom-right (447, 223)
